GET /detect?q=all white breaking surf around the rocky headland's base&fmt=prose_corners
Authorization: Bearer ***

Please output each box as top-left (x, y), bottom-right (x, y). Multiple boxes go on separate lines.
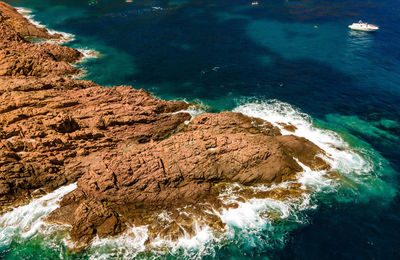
top-left (0, 100), bottom-right (395, 259)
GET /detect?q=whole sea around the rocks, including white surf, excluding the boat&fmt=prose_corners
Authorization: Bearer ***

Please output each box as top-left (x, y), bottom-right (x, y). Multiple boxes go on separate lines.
top-left (0, 0), bottom-right (400, 259)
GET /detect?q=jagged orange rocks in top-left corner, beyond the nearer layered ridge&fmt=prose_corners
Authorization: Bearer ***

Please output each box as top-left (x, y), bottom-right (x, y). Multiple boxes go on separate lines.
top-left (0, 2), bottom-right (83, 77)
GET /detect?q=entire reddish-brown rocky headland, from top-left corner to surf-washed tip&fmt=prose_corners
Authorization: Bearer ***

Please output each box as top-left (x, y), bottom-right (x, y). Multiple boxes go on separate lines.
top-left (0, 2), bottom-right (330, 249)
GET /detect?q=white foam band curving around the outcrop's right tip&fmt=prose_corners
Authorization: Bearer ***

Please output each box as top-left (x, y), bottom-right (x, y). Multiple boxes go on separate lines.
top-left (234, 100), bottom-right (394, 200)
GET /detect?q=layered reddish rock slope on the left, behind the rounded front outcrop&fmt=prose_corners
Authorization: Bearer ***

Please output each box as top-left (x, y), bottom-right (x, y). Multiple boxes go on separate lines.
top-left (0, 2), bottom-right (190, 212)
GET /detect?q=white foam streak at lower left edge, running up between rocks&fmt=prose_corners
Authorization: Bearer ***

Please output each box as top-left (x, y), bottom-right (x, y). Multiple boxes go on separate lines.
top-left (0, 183), bottom-right (77, 246)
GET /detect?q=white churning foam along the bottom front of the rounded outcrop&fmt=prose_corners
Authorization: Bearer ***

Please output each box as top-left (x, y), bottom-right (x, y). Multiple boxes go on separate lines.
top-left (85, 184), bottom-right (313, 259)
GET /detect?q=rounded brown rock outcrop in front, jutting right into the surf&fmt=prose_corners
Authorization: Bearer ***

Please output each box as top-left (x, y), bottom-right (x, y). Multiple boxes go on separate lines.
top-left (50, 112), bottom-right (329, 245)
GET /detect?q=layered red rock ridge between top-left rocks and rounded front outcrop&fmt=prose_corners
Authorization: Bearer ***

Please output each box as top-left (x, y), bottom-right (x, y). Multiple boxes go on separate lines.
top-left (0, 77), bottom-right (190, 211)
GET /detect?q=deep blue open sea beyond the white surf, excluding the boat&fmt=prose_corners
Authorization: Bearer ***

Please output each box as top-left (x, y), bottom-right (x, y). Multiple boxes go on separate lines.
top-left (3, 0), bottom-right (400, 259)
